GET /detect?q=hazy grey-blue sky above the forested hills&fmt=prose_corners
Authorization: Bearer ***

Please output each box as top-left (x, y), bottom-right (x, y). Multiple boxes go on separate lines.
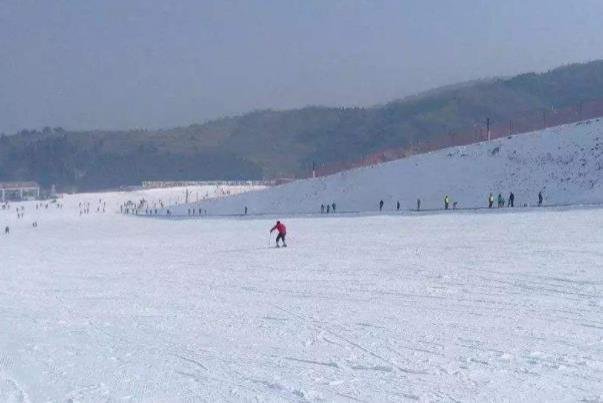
top-left (0, 0), bottom-right (603, 133)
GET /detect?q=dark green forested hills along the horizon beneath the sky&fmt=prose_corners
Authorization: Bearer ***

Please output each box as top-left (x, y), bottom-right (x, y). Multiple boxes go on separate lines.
top-left (0, 61), bottom-right (603, 190)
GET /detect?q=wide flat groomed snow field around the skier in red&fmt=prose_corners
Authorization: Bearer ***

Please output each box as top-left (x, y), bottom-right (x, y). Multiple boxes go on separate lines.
top-left (0, 195), bottom-right (603, 402)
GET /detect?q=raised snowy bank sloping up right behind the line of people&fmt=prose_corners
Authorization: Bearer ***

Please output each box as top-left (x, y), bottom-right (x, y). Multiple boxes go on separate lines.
top-left (174, 119), bottom-right (603, 215)
